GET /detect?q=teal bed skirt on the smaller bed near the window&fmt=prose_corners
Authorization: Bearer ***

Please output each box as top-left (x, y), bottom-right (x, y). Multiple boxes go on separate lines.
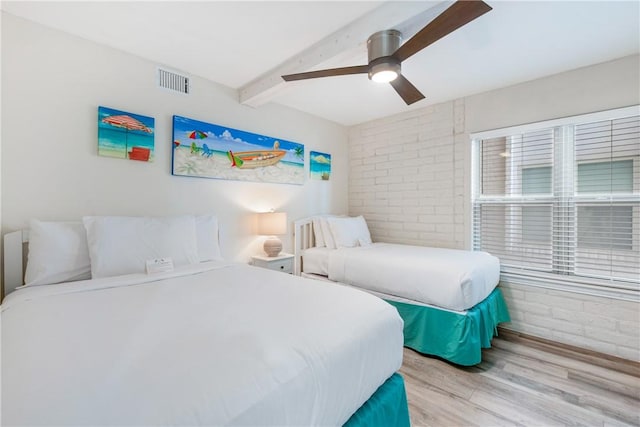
top-left (386, 288), bottom-right (511, 366)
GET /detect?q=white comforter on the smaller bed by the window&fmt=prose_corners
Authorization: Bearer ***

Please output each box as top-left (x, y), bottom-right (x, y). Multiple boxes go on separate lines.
top-left (329, 243), bottom-right (500, 311)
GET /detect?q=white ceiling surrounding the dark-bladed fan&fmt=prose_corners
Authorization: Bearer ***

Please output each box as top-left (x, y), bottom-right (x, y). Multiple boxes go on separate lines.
top-left (1, 0), bottom-right (640, 125)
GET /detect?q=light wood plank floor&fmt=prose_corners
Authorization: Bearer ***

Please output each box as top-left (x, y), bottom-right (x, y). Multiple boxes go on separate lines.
top-left (400, 338), bottom-right (640, 427)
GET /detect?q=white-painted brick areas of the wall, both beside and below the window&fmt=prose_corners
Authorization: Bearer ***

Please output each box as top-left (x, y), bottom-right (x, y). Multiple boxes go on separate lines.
top-left (349, 100), bottom-right (640, 361)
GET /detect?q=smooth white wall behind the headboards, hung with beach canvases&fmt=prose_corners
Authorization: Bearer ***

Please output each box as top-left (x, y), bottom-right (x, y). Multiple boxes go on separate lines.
top-left (1, 12), bottom-right (348, 270)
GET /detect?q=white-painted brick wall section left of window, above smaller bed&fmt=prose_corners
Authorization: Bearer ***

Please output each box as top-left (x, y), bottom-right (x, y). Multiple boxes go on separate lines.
top-left (349, 101), bottom-right (469, 248)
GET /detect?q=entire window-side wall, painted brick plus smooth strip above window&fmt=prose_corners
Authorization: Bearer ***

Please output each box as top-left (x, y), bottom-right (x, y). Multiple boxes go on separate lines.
top-left (349, 55), bottom-right (640, 361)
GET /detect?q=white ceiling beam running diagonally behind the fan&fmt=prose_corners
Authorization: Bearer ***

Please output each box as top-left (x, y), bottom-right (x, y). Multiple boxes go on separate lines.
top-left (238, 1), bottom-right (453, 107)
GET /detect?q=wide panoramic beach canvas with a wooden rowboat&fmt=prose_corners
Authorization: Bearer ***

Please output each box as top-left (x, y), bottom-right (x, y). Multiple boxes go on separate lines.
top-left (172, 116), bottom-right (304, 184)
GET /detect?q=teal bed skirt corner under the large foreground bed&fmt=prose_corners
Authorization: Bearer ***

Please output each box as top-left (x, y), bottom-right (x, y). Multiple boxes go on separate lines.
top-left (344, 373), bottom-right (411, 427)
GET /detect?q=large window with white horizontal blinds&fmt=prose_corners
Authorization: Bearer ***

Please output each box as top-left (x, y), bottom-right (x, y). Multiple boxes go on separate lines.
top-left (472, 107), bottom-right (640, 298)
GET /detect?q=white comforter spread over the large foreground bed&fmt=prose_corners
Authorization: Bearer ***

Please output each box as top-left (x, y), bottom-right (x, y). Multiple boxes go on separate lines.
top-left (1, 263), bottom-right (403, 425)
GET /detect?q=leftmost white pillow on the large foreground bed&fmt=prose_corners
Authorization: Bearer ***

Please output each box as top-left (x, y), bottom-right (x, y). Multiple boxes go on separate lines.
top-left (24, 219), bottom-right (91, 285)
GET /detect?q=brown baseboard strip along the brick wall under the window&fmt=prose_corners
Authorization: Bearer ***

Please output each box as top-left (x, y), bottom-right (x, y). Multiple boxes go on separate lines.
top-left (498, 326), bottom-right (640, 378)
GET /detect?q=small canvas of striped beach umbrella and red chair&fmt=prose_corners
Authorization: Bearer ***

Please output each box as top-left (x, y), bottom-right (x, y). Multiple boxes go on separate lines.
top-left (98, 107), bottom-right (155, 162)
